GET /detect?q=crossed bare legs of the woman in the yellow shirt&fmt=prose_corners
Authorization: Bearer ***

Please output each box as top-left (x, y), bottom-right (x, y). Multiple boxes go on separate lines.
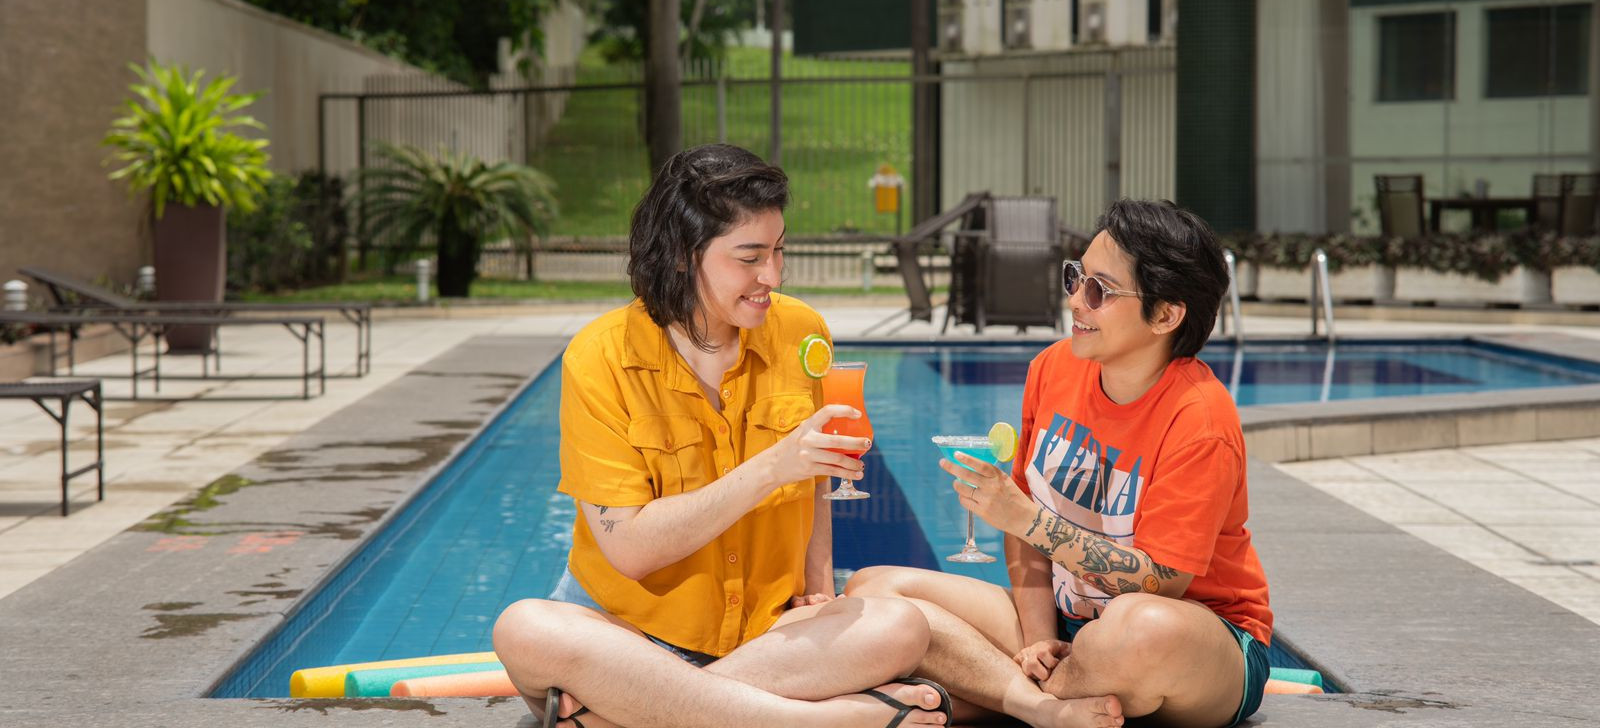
top-left (494, 598), bottom-right (944, 728)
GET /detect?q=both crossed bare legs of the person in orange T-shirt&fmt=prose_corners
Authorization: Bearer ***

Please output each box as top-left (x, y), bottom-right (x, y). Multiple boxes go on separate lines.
top-left (845, 566), bottom-right (1245, 726)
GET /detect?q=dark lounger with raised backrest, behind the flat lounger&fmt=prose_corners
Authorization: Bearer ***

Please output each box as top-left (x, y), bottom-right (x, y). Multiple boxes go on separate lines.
top-left (18, 266), bottom-right (373, 376)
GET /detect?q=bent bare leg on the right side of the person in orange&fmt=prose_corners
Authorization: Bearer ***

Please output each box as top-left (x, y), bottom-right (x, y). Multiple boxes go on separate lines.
top-left (1042, 594), bottom-right (1245, 726)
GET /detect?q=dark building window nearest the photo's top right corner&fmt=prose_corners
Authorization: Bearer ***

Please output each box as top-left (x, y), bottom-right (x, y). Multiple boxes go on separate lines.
top-left (1483, 3), bottom-right (1590, 99)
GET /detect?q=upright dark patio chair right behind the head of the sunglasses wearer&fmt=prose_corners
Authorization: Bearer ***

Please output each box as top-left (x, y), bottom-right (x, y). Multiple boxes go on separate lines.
top-left (946, 197), bottom-right (1066, 333)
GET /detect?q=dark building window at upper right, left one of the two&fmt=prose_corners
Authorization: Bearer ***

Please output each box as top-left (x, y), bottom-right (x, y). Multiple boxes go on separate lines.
top-left (1378, 13), bottom-right (1456, 101)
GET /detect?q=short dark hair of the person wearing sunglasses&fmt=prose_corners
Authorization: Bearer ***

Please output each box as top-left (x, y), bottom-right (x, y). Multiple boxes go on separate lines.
top-left (1096, 200), bottom-right (1229, 357)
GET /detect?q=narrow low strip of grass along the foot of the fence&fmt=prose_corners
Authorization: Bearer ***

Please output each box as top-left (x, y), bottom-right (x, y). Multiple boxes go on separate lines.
top-left (240, 275), bottom-right (934, 302)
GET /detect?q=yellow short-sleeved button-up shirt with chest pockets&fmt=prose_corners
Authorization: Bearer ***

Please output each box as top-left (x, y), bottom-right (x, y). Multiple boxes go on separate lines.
top-left (560, 293), bottom-right (829, 656)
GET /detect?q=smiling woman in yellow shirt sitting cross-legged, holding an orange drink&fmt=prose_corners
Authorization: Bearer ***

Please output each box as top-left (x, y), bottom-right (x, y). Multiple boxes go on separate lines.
top-left (494, 144), bottom-right (949, 728)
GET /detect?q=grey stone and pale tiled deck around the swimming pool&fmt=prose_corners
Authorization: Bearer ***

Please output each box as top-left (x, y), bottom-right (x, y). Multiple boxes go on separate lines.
top-left (0, 304), bottom-right (1600, 726)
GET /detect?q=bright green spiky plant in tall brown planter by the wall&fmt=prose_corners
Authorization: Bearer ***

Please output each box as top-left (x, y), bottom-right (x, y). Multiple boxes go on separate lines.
top-left (104, 61), bottom-right (272, 350)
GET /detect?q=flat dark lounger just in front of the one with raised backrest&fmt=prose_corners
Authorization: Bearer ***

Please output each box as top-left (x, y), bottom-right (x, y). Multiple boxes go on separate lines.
top-left (0, 309), bottom-right (328, 400)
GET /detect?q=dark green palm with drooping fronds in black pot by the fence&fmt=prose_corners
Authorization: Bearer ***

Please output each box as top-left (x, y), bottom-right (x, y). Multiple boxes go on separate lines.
top-left (358, 142), bottom-right (557, 296)
